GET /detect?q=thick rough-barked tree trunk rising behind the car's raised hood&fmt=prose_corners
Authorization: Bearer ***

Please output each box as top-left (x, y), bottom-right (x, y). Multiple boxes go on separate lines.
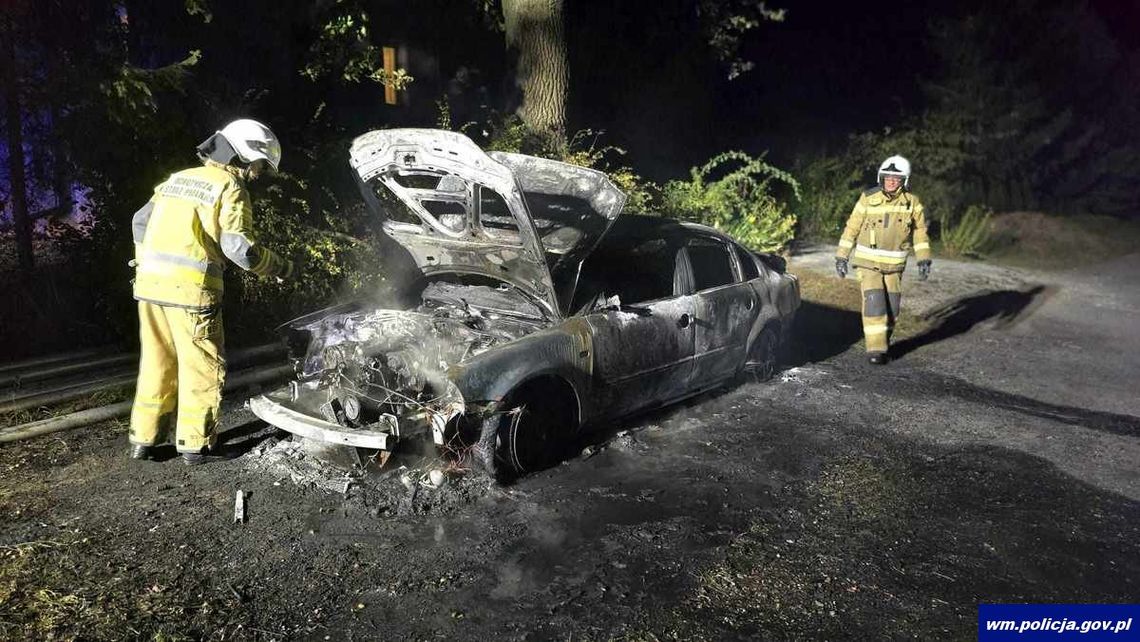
top-left (503, 0), bottom-right (569, 151)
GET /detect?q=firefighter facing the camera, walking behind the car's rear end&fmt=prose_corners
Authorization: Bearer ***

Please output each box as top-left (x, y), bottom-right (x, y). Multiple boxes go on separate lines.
top-left (836, 156), bottom-right (930, 365)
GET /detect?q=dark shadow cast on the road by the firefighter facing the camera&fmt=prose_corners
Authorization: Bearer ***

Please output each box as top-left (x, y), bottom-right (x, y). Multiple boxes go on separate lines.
top-left (890, 285), bottom-right (1056, 358)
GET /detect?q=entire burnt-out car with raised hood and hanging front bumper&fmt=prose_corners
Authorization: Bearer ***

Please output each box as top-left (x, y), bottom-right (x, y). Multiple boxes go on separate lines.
top-left (251, 129), bottom-right (799, 477)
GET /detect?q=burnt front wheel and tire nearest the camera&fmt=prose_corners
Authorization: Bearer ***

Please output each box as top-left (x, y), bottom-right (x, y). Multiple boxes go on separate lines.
top-left (479, 380), bottom-right (577, 481)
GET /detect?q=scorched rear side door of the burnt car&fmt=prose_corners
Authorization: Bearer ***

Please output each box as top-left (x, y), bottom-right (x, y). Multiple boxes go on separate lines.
top-left (685, 237), bottom-right (759, 389)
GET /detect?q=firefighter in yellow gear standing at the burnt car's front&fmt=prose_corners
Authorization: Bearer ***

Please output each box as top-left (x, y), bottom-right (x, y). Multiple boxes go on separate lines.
top-left (130, 120), bottom-right (293, 464)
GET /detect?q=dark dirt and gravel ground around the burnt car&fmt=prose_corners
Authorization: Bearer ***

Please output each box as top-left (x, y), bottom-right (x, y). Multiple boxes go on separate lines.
top-left (0, 250), bottom-right (1140, 640)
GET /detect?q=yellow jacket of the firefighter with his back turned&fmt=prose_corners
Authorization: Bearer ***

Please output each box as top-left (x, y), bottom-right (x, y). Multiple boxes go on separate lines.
top-left (131, 161), bottom-right (292, 309)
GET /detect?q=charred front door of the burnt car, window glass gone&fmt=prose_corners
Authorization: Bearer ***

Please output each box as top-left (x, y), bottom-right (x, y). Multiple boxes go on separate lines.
top-left (583, 239), bottom-right (695, 416)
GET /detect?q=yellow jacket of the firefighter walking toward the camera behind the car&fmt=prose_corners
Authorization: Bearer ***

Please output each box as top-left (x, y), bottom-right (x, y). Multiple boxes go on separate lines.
top-left (836, 187), bottom-right (930, 274)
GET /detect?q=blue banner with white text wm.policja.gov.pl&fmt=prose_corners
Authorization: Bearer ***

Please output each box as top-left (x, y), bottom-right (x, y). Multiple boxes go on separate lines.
top-left (978, 604), bottom-right (1140, 642)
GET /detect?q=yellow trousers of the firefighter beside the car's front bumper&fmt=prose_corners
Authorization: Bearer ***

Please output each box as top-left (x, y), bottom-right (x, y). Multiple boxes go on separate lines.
top-left (130, 301), bottom-right (226, 453)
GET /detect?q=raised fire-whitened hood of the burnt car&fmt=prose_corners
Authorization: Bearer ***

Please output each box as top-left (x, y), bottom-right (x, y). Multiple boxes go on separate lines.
top-left (350, 129), bottom-right (625, 318)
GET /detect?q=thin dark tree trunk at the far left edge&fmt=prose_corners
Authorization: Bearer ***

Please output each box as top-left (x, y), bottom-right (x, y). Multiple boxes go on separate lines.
top-left (0, 17), bottom-right (34, 274)
